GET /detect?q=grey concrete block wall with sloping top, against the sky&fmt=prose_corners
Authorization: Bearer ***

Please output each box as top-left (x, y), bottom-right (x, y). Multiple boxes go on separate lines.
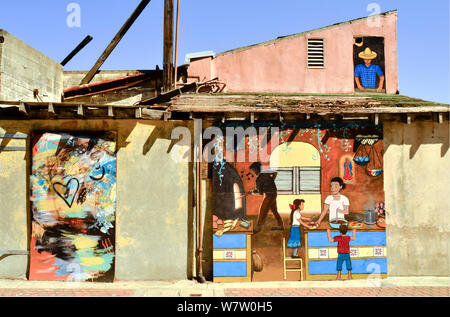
top-left (0, 30), bottom-right (63, 102)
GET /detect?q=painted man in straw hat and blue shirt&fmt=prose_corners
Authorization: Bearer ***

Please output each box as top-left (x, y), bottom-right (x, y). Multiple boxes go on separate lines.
top-left (355, 47), bottom-right (384, 92)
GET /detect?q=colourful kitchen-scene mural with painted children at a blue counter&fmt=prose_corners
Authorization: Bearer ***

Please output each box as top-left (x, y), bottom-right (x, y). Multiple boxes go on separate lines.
top-left (212, 123), bottom-right (387, 282)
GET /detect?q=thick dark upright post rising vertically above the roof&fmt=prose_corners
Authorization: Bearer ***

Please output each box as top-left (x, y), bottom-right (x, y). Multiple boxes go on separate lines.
top-left (163, 0), bottom-right (174, 92)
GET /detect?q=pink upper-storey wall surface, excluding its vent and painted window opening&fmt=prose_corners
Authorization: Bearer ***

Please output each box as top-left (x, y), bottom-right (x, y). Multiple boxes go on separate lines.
top-left (188, 11), bottom-right (398, 94)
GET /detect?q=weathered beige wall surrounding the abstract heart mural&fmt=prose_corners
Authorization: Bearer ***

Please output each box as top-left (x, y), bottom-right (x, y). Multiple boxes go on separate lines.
top-left (0, 120), bottom-right (192, 280)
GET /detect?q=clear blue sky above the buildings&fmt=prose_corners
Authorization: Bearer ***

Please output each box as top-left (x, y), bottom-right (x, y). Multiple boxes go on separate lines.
top-left (0, 0), bottom-right (450, 103)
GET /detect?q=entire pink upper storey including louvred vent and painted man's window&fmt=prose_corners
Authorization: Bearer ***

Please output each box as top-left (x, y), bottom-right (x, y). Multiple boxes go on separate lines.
top-left (187, 11), bottom-right (398, 94)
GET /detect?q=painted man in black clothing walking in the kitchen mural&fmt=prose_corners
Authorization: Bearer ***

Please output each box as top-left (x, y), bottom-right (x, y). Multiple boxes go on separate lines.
top-left (250, 162), bottom-right (284, 233)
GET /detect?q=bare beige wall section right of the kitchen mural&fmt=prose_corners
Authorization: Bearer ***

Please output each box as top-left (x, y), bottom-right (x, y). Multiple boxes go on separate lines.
top-left (384, 121), bottom-right (450, 277)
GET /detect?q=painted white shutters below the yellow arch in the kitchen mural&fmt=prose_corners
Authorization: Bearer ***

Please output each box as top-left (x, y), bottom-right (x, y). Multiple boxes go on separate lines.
top-left (275, 166), bottom-right (320, 195)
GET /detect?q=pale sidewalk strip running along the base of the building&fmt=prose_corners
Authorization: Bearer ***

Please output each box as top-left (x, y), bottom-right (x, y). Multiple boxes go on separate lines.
top-left (0, 277), bottom-right (450, 297)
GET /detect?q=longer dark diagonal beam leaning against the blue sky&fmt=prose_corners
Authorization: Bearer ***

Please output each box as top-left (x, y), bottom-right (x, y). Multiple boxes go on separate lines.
top-left (81, 0), bottom-right (151, 85)
